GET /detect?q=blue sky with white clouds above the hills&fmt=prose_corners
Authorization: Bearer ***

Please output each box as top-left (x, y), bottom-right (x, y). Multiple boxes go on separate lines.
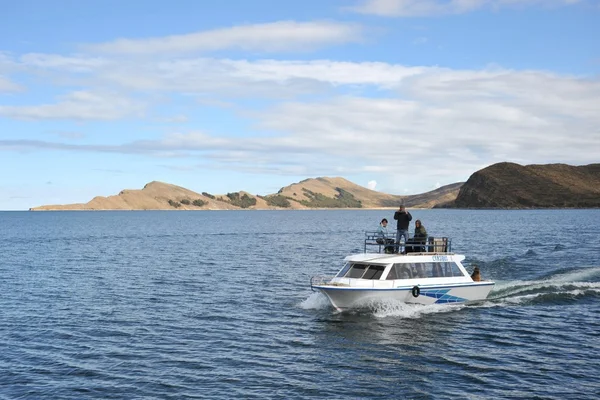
top-left (0, 0), bottom-right (600, 210)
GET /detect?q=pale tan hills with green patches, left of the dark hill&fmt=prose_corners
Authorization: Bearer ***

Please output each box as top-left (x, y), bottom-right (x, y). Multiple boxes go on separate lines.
top-left (30, 177), bottom-right (462, 211)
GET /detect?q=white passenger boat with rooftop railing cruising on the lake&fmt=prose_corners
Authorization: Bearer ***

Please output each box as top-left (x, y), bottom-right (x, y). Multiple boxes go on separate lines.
top-left (310, 232), bottom-right (495, 311)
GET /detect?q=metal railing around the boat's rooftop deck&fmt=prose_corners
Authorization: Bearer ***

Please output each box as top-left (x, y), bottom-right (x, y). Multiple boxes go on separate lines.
top-left (364, 231), bottom-right (452, 254)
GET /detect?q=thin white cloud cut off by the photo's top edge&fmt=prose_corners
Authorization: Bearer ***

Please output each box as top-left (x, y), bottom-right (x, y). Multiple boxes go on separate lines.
top-left (349, 0), bottom-right (579, 17)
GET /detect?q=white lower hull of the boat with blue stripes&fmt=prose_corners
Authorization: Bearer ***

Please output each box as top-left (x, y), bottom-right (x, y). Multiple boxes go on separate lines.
top-left (313, 281), bottom-right (494, 311)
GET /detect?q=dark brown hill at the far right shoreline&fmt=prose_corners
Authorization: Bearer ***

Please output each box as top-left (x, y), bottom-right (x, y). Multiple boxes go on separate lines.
top-left (445, 162), bottom-right (600, 209)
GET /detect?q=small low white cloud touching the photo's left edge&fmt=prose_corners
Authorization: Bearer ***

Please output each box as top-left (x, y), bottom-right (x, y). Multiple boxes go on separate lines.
top-left (0, 91), bottom-right (144, 120)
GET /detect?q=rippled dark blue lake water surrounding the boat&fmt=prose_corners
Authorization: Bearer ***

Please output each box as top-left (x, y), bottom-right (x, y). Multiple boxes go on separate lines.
top-left (0, 210), bottom-right (600, 399)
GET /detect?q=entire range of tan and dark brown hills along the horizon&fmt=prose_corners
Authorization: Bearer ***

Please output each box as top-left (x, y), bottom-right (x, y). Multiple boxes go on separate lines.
top-left (30, 162), bottom-right (600, 211)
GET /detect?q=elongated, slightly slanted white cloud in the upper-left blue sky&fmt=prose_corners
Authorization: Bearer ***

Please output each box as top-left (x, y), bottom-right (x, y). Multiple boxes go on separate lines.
top-left (84, 21), bottom-right (361, 55)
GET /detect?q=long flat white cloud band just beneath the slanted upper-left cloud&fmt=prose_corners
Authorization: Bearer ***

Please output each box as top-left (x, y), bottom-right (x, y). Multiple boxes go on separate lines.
top-left (21, 55), bottom-right (431, 94)
